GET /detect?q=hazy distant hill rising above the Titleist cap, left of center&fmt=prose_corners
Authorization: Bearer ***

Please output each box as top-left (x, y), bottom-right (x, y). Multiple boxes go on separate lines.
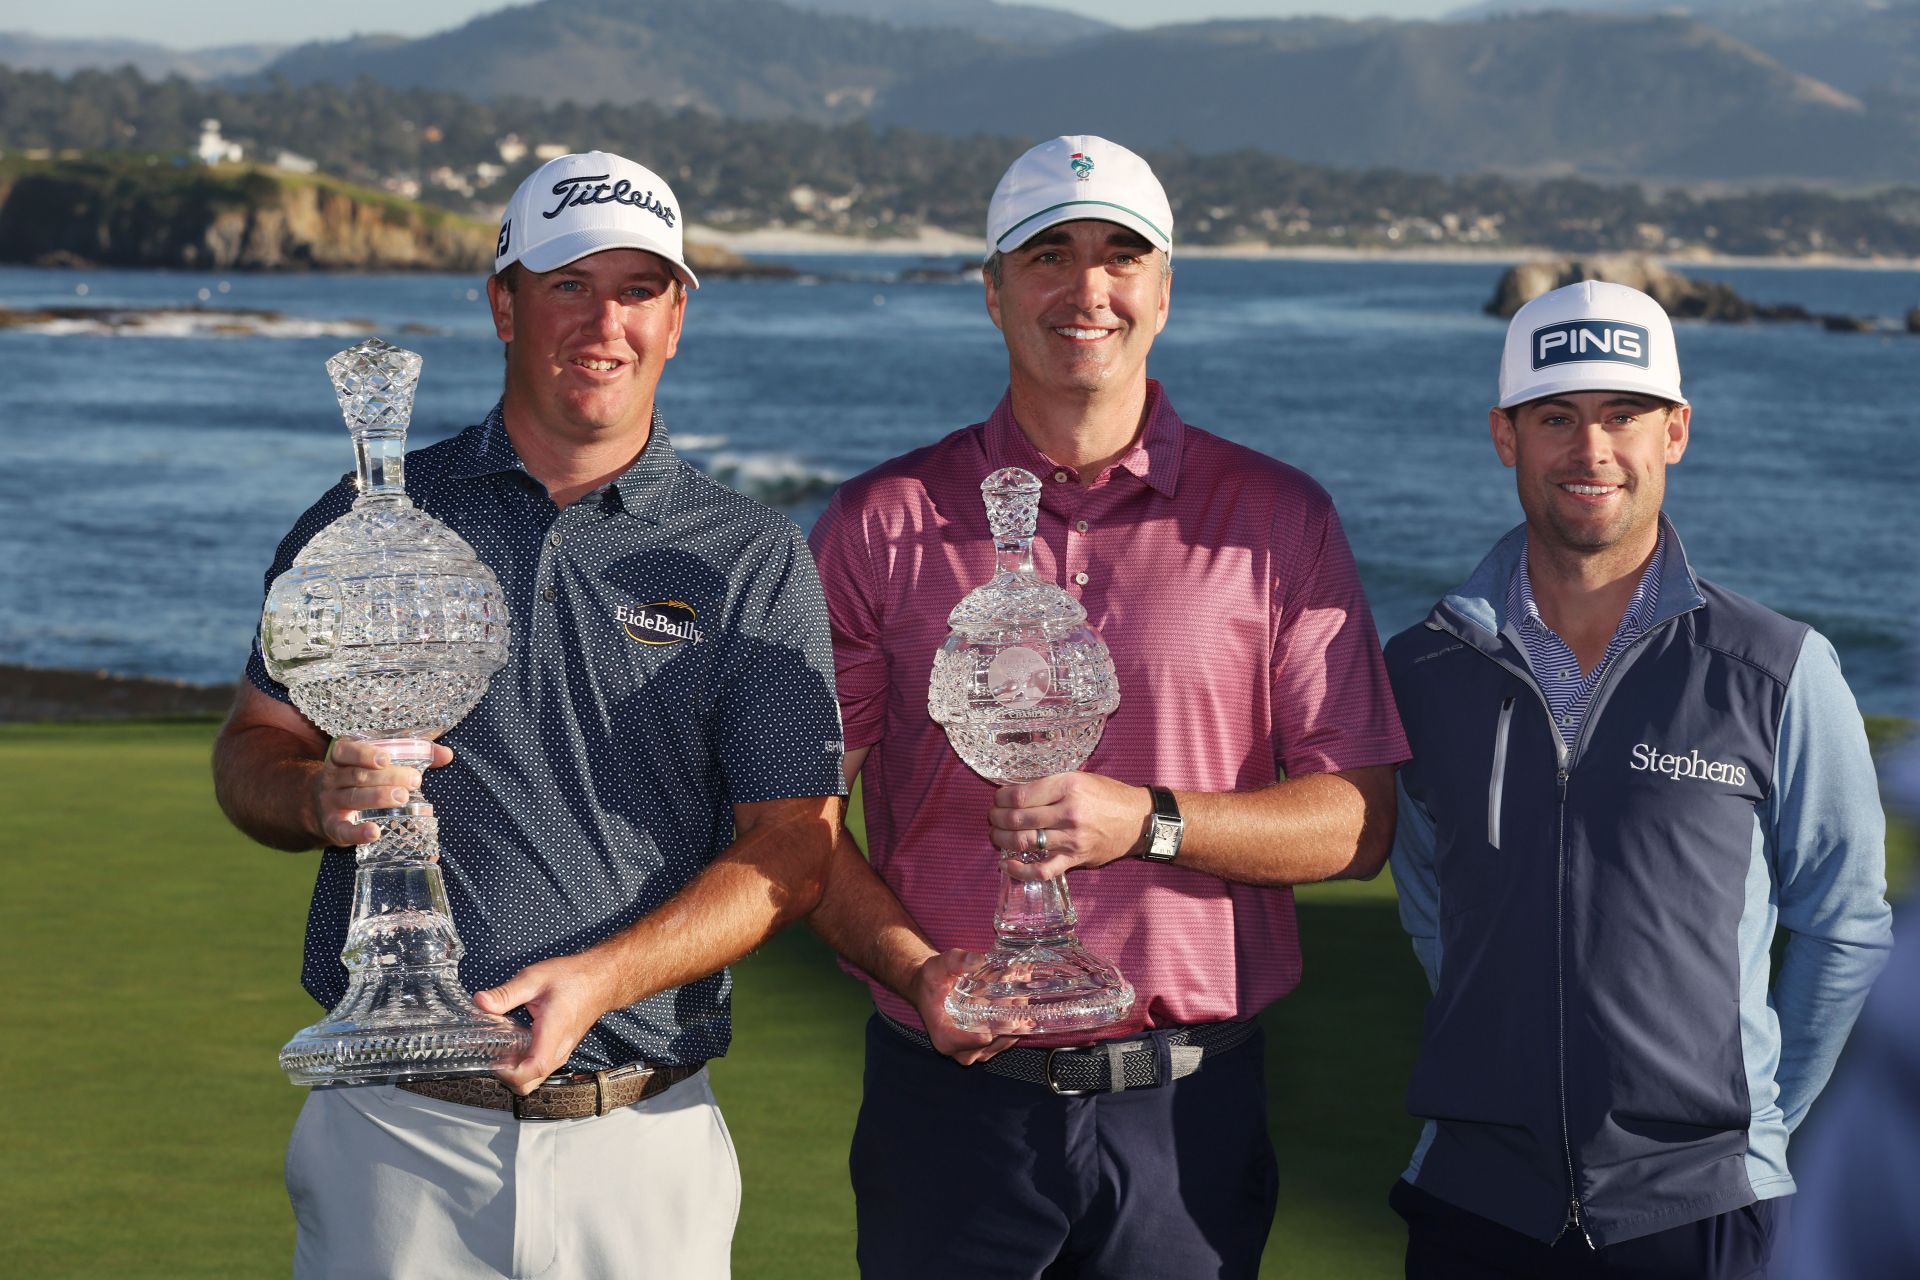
top-left (265, 0), bottom-right (998, 121)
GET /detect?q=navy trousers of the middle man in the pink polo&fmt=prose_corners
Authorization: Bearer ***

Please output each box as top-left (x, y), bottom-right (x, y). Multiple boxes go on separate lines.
top-left (849, 1017), bottom-right (1279, 1280)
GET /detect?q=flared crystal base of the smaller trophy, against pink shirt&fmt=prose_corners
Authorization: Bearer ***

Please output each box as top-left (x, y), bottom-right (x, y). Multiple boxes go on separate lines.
top-left (947, 938), bottom-right (1133, 1036)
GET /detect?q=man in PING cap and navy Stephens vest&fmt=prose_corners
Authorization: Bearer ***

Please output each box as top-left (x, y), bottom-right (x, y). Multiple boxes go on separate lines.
top-left (1386, 282), bottom-right (1891, 1280)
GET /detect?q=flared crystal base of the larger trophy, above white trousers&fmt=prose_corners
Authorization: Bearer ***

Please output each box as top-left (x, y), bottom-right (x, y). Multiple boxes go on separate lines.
top-left (280, 973), bottom-right (534, 1084)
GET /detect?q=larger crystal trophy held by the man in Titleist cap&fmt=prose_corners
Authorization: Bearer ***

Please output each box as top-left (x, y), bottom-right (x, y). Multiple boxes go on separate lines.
top-left (259, 338), bottom-right (532, 1084)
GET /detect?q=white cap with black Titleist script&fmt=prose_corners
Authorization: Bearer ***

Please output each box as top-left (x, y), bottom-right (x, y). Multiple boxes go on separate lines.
top-left (493, 152), bottom-right (701, 290)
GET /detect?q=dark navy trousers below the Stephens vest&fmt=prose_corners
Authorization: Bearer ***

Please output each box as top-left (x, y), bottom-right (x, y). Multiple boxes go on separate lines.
top-left (1388, 1180), bottom-right (1791, 1280)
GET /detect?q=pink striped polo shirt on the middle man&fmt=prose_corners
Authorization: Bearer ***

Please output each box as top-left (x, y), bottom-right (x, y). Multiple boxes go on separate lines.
top-left (810, 382), bottom-right (1409, 1038)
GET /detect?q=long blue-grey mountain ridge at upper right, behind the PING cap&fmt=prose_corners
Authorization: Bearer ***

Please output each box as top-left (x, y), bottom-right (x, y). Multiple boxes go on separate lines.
top-left (874, 13), bottom-right (1920, 182)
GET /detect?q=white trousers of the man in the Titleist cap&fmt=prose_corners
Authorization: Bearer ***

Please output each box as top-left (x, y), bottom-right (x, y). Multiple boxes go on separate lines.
top-left (286, 1071), bottom-right (739, 1280)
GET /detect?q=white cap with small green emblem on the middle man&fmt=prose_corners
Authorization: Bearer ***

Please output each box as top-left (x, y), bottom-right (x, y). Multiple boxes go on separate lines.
top-left (987, 134), bottom-right (1173, 253)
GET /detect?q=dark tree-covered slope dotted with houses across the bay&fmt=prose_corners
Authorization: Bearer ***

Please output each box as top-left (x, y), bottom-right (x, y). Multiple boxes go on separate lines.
top-left (11, 67), bottom-right (1920, 271)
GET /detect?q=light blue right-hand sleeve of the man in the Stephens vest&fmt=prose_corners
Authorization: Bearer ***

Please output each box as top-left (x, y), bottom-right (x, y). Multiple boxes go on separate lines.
top-left (1766, 631), bottom-right (1893, 1130)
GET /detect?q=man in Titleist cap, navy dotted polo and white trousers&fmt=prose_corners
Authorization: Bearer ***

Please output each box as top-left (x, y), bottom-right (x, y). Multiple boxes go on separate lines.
top-left (215, 152), bottom-right (845, 1278)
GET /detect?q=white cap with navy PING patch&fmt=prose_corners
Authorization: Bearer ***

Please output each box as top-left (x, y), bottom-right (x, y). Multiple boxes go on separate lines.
top-left (1500, 280), bottom-right (1686, 409)
